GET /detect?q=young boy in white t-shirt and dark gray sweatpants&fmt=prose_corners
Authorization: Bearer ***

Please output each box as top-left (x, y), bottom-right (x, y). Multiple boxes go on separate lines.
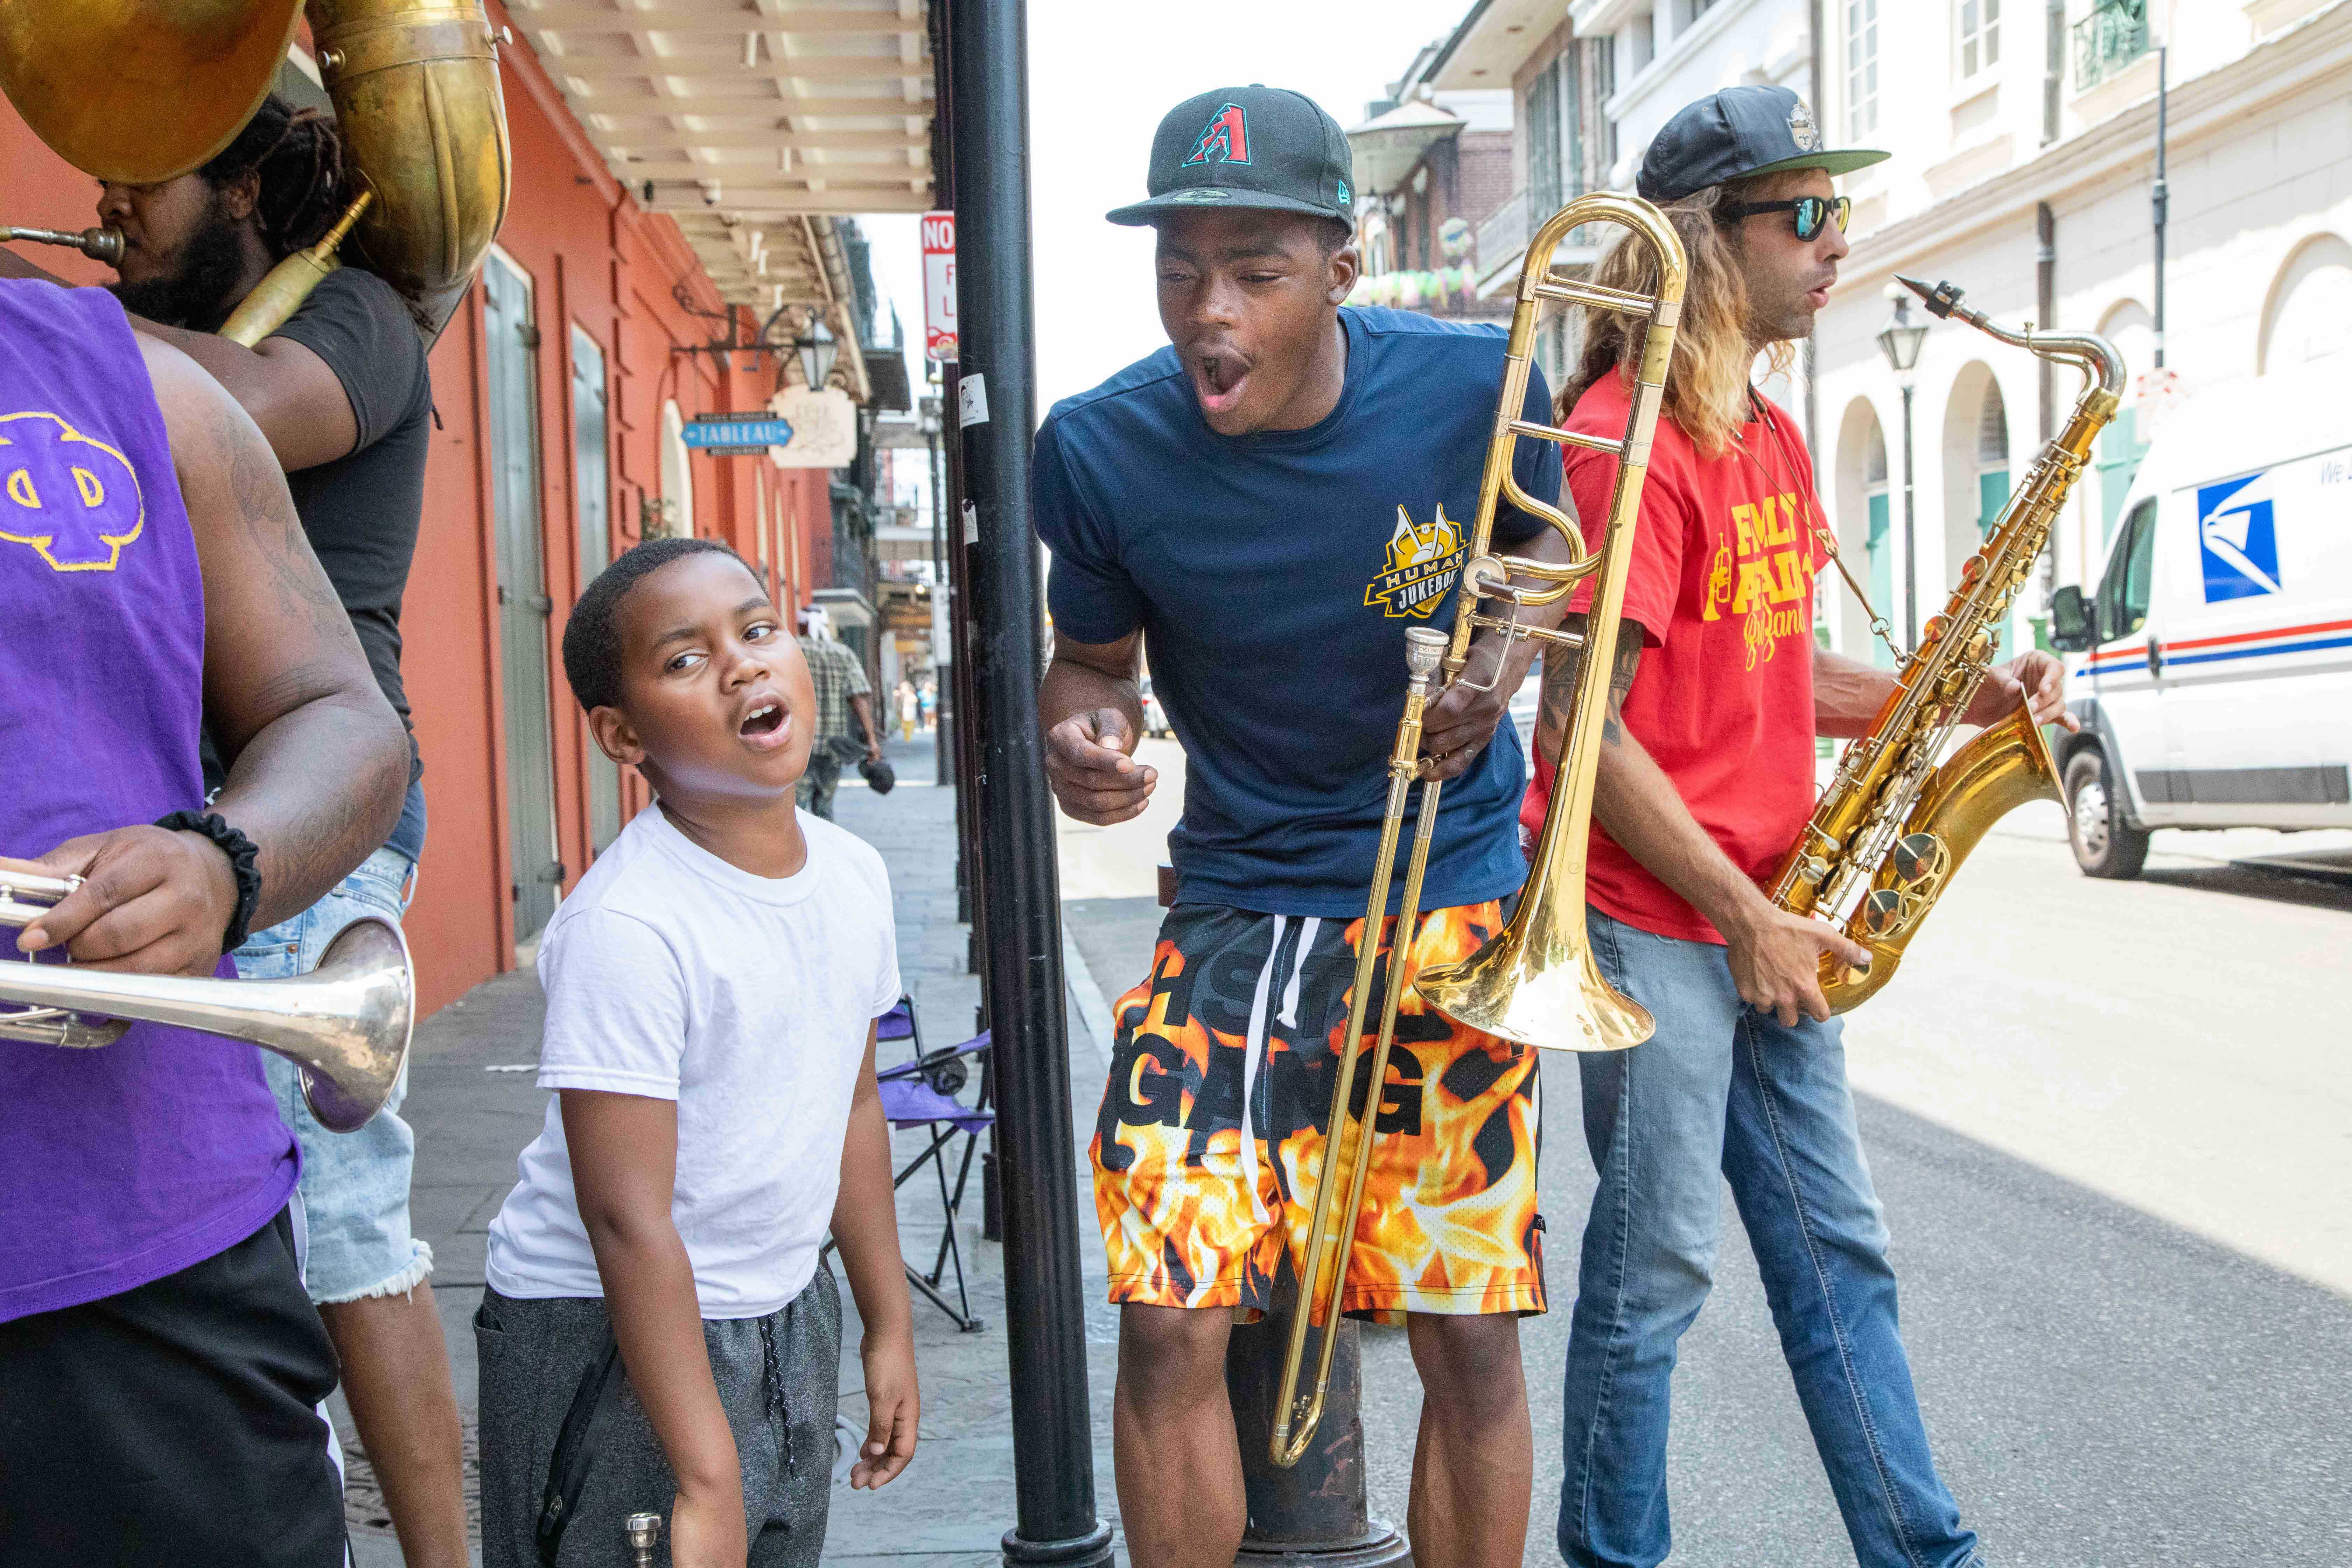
top-left (475, 538), bottom-right (920, 1568)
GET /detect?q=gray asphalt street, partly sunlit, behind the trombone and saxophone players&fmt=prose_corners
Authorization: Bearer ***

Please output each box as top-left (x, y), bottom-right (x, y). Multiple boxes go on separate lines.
top-left (1061, 743), bottom-right (2352, 1568)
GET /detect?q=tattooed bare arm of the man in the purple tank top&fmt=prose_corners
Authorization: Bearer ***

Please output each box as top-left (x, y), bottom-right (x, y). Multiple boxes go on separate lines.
top-left (19, 338), bottom-right (409, 973)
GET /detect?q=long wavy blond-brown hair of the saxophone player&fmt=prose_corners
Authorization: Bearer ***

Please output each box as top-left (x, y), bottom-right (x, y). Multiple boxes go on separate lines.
top-left (1557, 174), bottom-right (1794, 458)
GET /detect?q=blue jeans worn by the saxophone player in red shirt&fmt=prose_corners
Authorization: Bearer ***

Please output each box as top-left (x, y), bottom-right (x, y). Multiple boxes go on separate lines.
top-left (1559, 910), bottom-right (1980, 1568)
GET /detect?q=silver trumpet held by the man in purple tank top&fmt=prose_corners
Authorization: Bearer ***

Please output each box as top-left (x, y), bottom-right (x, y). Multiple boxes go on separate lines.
top-left (0, 872), bottom-right (416, 1133)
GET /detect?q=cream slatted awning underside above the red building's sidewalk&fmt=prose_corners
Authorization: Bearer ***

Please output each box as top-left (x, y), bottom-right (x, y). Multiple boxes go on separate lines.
top-left (508, 0), bottom-right (931, 320)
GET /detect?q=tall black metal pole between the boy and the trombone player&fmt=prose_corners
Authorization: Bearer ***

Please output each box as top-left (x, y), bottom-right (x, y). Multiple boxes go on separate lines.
top-left (948, 0), bottom-right (1113, 1566)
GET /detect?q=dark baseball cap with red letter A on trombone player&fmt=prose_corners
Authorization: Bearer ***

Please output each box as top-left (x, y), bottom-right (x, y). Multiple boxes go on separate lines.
top-left (1108, 82), bottom-right (1355, 226)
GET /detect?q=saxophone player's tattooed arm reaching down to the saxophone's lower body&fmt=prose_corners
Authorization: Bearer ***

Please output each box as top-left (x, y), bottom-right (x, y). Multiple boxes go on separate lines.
top-left (1536, 616), bottom-right (1868, 1025)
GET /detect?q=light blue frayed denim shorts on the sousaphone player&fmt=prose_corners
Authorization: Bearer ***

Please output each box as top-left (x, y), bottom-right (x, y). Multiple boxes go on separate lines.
top-left (238, 849), bottom-right (433, 1307)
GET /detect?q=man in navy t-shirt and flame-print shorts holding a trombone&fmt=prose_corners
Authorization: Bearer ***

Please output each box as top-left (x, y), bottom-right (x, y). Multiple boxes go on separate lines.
top-left (1035, 87), bottom-right (1567, 1568)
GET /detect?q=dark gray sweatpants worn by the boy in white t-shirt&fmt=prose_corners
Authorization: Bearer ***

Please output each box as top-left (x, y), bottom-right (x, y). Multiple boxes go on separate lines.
top-left (473, 1267), bottom-right (842, 1568)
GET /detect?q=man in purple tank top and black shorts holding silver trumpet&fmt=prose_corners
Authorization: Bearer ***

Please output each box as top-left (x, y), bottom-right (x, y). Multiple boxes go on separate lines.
top-left (0, 282), bottom-right (409, 1568)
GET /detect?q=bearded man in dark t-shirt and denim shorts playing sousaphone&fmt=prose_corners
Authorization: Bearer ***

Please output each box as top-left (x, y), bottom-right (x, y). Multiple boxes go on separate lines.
top-left (0, 94), bottom-right (466, 1568)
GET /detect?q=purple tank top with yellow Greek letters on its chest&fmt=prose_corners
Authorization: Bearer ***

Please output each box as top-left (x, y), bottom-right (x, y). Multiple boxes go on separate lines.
top-left (0, 280), bottom-right (296, 1321)
